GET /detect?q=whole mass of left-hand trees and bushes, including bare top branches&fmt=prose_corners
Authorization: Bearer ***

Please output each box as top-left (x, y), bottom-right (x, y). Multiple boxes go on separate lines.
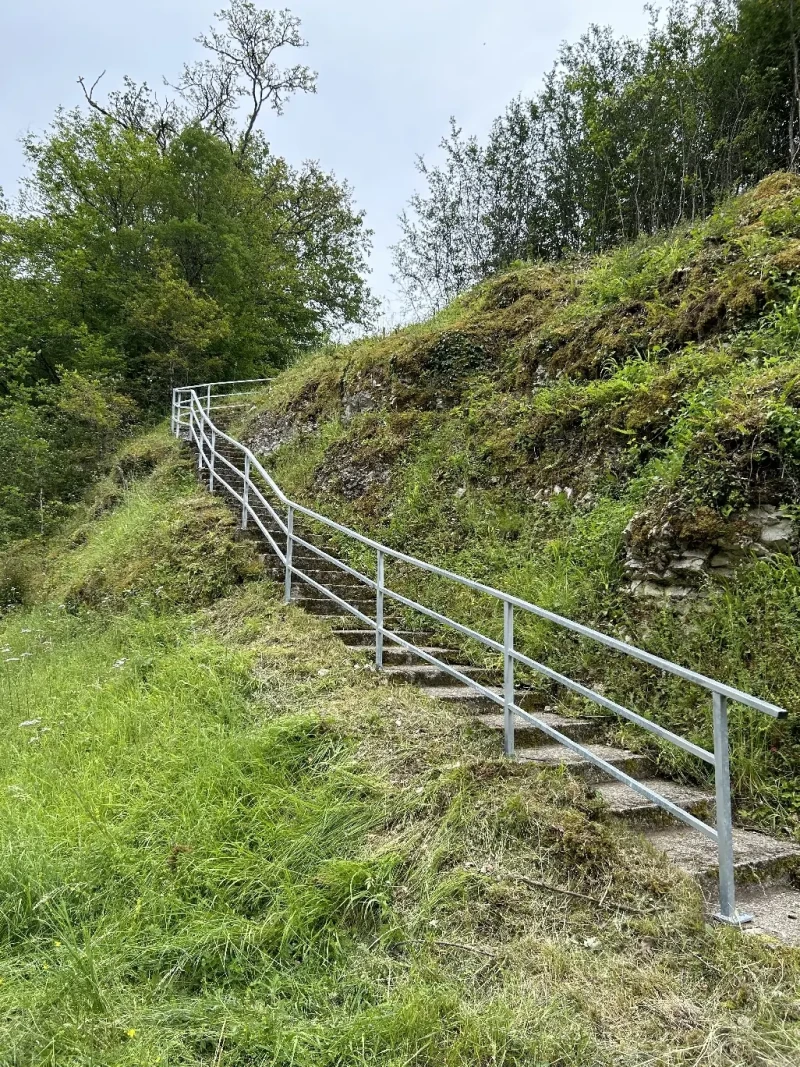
top-left (0, 0), bottom-right (369, 543)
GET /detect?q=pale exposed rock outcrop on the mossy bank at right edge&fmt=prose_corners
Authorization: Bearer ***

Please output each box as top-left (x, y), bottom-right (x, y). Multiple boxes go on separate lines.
top-left (625, 504), bottom-right (798, 600)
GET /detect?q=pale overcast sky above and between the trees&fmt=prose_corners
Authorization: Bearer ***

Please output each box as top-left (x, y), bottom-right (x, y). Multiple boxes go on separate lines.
top-left (0, 0), bottom-right (646, 312)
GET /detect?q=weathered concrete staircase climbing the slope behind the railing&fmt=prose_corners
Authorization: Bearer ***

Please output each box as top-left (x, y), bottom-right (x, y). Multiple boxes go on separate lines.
top-left (181, 399), bottom-right (800, 945)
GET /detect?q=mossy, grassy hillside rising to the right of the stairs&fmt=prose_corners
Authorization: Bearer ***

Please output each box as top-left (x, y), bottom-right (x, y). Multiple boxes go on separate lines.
top-left (238, 174), bottom-right (800, 831)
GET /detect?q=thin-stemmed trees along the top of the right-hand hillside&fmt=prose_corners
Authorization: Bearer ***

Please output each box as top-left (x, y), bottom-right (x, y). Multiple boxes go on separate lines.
top-left (395, 0), bottom-right (800, 310)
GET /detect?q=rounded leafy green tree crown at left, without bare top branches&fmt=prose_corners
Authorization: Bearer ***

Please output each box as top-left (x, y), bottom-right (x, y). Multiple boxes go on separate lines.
top-left (2, 112), bottom-right (368, 405)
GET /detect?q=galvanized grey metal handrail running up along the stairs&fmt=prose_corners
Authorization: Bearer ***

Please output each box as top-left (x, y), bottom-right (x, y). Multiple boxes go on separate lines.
top-left (172, 379), bottom-right (787, 925)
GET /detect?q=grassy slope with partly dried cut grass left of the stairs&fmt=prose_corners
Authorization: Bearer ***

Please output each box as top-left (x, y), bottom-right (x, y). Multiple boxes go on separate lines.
top-left (0, 433), bottom-right (800, 1067)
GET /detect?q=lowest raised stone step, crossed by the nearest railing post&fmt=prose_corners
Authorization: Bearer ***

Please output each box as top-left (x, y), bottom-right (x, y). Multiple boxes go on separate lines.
top-left (644, 824), bottom-right (800, 886)
